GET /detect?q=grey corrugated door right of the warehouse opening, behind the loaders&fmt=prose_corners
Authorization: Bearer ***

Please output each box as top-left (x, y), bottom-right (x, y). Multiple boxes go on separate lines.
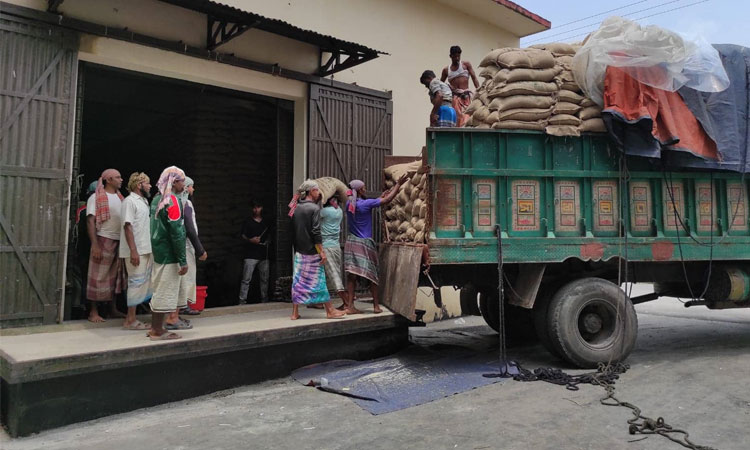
top-left (308, 84), bottom-right (393, 240)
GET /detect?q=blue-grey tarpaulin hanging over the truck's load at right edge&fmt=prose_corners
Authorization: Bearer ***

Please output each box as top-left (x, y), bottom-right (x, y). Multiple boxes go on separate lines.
top-left (670, 44), bottom-right (750, 173)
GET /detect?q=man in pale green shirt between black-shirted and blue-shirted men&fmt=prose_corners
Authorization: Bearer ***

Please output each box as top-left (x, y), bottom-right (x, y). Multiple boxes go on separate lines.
top-left (320, 196), bottom-right (347, 310)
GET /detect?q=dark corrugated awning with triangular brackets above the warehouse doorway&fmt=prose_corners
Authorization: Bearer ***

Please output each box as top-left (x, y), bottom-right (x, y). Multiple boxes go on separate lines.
top-left (160, 0), bottom-right (387, 77)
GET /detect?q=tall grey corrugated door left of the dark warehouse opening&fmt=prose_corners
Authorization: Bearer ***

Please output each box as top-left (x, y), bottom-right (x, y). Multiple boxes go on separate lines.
top-left (0, 15), bottom-right (78, 326)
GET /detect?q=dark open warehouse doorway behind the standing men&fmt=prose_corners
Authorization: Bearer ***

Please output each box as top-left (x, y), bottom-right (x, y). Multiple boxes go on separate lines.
top-left (66, 63), bottom-right (294, 320)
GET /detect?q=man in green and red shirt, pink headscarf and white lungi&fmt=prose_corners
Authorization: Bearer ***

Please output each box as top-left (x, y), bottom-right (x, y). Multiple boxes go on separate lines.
top-left (148, 166), bottom-right (188, 341)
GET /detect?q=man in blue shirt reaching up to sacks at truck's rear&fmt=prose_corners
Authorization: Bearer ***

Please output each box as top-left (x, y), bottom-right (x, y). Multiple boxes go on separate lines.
top-left (344, 174), bottom-right (407, 314)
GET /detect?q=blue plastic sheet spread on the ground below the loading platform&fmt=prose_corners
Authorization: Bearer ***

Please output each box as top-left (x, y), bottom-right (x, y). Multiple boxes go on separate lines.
top-left (292, 346), bottom-right (507, 415)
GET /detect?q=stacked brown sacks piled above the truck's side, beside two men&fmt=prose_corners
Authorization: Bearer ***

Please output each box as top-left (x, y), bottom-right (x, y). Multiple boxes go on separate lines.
top-left (465, 43), bottom-right (606, 136)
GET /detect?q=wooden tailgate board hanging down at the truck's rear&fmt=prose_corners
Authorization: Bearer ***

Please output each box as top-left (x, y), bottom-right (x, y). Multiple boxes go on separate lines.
top-left (379, 243), bottom-right (424, 322)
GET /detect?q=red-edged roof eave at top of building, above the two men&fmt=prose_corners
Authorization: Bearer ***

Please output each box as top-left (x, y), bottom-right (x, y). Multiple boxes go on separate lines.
top-left (438, 0), bottom-right (552, 38)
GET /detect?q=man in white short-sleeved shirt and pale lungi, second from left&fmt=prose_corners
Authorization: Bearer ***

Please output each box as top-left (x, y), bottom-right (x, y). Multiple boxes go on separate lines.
top-left (120, 172), bottom-right (153, 330)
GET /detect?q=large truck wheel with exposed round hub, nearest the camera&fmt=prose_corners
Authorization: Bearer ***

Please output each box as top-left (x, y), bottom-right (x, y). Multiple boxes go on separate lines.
top-left (547, 278), bottom-right (638, 369)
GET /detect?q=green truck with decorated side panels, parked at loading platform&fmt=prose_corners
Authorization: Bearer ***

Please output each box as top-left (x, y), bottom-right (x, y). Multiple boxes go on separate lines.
top-left (381, 128), bottom-right (750, 367)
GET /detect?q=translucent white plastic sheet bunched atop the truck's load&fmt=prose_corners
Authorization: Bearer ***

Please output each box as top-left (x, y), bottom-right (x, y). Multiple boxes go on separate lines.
top-left (573, 17), bottom-right (729, 106)
